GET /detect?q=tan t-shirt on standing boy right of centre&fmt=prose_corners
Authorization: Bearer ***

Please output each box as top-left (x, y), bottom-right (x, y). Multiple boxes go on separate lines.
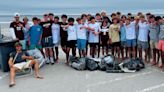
top-left (109, 24), bottom-right (120, 43)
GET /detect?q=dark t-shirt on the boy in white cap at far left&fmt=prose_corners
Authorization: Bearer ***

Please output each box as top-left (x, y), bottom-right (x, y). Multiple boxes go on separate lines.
top-left (10, 22), bottom-right (24, 40)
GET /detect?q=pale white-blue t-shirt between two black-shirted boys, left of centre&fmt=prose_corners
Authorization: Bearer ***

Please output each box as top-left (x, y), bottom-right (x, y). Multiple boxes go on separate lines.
top-left (52, 23), bottom-right (60, 44)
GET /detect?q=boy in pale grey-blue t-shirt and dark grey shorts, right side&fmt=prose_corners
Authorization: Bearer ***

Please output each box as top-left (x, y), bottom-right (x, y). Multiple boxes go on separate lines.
top-left (137, 15), bottom-right (149, 63)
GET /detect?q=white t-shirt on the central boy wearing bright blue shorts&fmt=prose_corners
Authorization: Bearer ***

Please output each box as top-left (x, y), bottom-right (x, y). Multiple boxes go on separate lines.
top-left (76, 24), bottom-right (88, 40)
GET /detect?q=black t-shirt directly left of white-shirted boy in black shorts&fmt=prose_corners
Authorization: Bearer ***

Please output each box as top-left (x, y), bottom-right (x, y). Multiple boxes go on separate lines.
top-left (59, 22), bottom-right (68, 39)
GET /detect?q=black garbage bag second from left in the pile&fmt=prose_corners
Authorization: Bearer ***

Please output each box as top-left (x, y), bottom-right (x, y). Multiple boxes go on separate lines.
top-left (86, 58), bottom-right (98, 71)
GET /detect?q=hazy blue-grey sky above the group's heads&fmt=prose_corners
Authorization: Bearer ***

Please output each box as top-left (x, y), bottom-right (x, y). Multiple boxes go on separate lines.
top-left (0, 0), bottom-right (164, 15)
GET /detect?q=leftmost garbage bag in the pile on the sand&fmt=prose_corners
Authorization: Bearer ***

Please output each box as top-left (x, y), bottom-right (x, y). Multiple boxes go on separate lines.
top-left (71, 58), bottom-right (86, 70)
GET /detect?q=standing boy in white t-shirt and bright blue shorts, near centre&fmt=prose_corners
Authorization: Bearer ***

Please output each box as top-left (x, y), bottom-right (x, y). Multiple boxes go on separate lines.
top-left (76, 18), bottom-right (88, 57)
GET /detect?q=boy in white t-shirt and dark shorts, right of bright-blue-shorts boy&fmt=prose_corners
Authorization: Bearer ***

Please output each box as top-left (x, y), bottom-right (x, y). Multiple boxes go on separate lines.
top-left (88, 17), bottom-right (101, 58)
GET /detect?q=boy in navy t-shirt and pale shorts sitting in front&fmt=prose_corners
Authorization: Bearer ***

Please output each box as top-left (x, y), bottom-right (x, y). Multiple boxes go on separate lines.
top-left (8, 42), bottom-right (43, 87)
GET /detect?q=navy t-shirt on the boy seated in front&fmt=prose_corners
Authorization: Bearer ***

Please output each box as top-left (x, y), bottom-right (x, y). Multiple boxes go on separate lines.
top-left (10, 52), bottom-right (29, 64)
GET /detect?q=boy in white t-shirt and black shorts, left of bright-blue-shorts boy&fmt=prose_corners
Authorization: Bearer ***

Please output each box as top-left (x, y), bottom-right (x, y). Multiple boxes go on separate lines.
top-left (66, 18), bottom-right (77, 64)
